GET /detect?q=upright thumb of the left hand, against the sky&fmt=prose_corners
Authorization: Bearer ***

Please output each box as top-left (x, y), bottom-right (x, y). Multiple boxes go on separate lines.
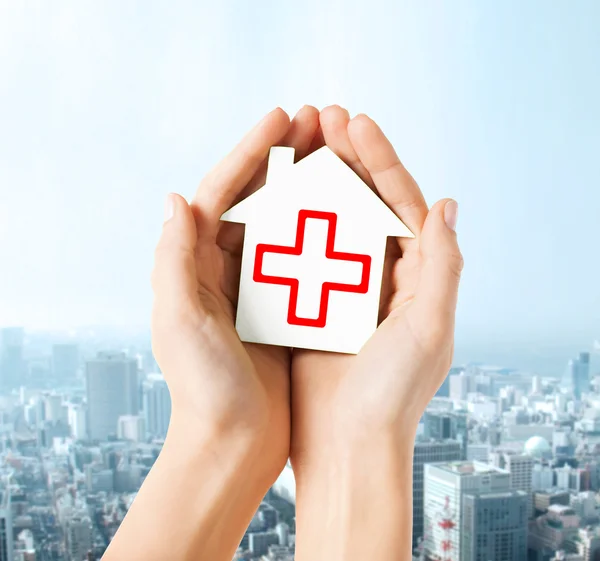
top-left (152, 193), bottom-right (198, 311)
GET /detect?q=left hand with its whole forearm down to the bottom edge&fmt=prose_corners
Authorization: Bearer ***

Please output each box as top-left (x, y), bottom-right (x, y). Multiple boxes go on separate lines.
top-left (103, 107), bottom-right (318, 561)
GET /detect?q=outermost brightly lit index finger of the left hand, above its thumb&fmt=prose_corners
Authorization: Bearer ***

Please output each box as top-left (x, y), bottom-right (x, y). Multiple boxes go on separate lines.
top-left (192, 108), bottom-right (290, 235)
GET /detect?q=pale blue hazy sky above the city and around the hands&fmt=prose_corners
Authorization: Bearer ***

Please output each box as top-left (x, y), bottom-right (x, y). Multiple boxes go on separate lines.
top-left (0, 0), bottom-right (600, 342)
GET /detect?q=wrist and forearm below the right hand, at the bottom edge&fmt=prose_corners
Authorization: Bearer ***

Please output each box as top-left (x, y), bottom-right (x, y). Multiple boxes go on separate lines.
top-left (295, 426), bottom-right (413, 561)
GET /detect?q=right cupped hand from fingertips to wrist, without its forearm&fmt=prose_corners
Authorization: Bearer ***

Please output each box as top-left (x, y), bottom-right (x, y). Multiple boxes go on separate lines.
top-left (291, 106), bottom-right (463, 468)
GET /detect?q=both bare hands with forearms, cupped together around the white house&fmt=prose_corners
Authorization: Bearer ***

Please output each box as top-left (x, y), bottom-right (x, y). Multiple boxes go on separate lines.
top-left (104, 106), bottom-right (462, 561)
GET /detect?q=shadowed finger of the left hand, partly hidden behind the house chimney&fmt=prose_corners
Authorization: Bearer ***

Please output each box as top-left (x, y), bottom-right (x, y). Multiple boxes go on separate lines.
top-left (240, 105), bottom-right (319, 201)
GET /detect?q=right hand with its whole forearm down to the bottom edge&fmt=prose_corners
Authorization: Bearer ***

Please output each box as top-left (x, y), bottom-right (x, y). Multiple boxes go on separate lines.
top-left (291, 106), bottom-right (463, 560)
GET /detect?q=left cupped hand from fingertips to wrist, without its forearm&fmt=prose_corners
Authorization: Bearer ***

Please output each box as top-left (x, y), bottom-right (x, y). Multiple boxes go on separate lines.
top-left (152, 107), bottom-right (319, 478)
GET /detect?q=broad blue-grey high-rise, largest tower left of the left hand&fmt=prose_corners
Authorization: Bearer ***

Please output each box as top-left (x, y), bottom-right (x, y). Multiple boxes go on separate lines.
top-left (85, 352), bottom-right (139, 440)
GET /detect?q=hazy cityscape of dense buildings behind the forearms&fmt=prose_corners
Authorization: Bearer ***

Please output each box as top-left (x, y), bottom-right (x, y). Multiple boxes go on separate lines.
top-left (0, 327), bottom-right (600, 561)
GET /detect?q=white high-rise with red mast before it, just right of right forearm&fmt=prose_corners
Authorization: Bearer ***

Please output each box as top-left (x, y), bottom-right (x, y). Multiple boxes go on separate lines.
top-left (423, 461), bottom-right (510, 560)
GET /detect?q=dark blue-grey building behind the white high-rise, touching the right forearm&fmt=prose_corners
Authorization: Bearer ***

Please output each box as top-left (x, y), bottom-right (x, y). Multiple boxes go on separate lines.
top-left (412, 440), bottom-right (461, 547)
